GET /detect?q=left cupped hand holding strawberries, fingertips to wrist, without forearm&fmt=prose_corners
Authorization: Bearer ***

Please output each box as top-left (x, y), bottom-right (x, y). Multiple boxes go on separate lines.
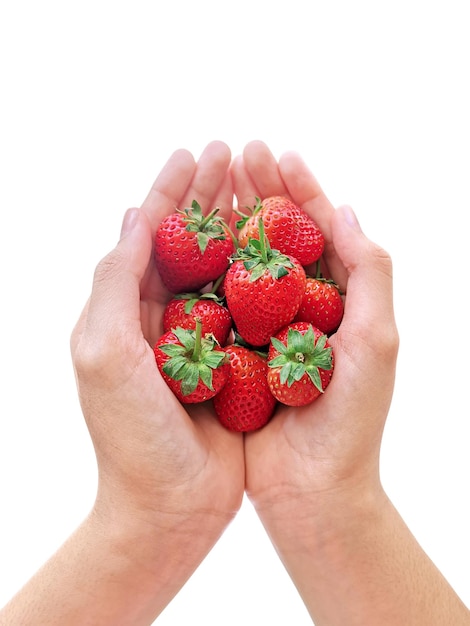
top-left (71, 142), bottom-right (244, 536)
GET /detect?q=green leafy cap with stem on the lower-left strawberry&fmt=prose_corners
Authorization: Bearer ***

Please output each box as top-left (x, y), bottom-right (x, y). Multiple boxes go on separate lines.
top-left (159, 318), bottom-right (227, 396)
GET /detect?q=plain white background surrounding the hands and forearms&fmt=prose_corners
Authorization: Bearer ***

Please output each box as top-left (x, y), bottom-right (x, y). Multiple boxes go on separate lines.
top-left (0, 0), bottom-right (470, 626)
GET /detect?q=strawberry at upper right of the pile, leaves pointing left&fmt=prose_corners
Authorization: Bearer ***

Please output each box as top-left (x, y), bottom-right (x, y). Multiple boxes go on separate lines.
top-left (237, 196), bottom-right (325, 266)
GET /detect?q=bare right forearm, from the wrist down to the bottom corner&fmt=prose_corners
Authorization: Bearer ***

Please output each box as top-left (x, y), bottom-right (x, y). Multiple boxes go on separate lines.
top-left (260, 493), bottom-right (470, 626)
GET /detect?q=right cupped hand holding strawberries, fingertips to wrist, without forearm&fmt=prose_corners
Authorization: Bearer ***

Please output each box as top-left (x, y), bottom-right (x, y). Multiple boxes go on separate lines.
top-left (232, 141), bottom-right (398, 515)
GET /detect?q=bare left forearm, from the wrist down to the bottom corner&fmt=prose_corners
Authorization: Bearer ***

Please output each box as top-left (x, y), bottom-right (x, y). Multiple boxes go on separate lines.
top-left (0, 502), bottom-right (228, 626)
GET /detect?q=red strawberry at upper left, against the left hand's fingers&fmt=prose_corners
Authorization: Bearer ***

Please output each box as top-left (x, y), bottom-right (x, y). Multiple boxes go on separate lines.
top-left (154, 200), bottom-right (235, 293)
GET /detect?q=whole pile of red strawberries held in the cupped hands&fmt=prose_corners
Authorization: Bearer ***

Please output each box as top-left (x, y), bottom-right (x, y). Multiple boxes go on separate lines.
top-left (154, 196), bottom-right (343, 432)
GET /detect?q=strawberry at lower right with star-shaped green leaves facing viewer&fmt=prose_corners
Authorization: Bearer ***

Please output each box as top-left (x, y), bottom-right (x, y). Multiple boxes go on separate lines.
top-left (268, 322), bottom-right (334, 406)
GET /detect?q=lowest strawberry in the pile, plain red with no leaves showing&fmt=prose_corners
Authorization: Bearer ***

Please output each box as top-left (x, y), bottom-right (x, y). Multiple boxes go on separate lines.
top-left (213, 344), bottom-right (277, 432)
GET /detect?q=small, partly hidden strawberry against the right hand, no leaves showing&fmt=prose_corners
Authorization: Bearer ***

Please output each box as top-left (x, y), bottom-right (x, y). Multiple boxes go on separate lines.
top-left (294, 276), bottom-right (344, 334)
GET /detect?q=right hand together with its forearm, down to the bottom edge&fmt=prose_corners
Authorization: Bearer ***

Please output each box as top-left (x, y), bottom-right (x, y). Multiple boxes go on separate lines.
top-left (232, 141), bottom-right (470, 626)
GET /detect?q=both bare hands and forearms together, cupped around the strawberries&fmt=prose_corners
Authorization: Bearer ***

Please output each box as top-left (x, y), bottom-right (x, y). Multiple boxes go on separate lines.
top-left (0, 141), bottom-right (470, 626)
